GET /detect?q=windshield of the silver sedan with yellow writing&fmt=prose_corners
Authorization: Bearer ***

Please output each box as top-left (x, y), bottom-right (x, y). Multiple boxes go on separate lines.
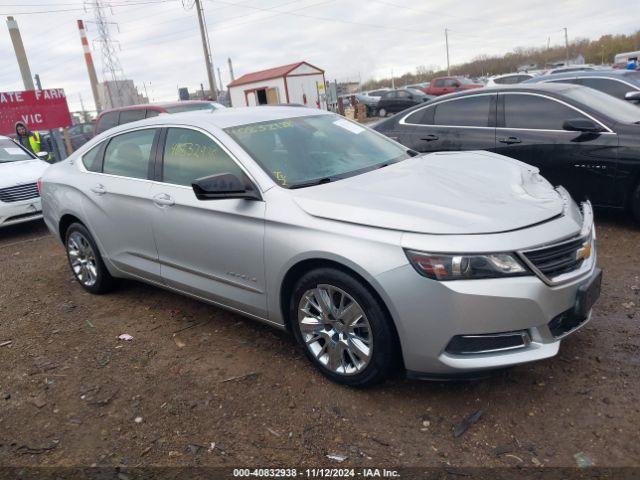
top-left (225, 115), bottom-right (409, 188)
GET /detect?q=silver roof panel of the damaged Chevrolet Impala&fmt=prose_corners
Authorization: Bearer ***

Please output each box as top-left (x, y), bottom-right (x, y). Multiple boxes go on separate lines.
top-left (95, 105), bottom-right (333, 135)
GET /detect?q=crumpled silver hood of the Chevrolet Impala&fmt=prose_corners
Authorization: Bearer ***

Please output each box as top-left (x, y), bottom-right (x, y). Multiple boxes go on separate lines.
top-left (293, 151), bottom-right (564, 234)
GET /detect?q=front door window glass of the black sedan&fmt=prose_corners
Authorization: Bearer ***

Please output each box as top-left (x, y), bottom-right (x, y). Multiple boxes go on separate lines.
top-left (504, 95), bottom-right (588, 130)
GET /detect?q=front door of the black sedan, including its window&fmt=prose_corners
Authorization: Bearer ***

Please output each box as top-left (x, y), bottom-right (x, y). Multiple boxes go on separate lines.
top-left (496, 92), bottom-right (618, 205)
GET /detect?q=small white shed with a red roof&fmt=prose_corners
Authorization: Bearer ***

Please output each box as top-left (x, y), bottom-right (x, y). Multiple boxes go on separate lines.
top-left (228, 62), bottom-right (325, 108)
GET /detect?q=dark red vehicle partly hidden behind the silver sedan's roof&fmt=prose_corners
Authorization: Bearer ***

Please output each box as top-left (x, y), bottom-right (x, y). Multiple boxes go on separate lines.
top-left (93, 100), bottom-right (226, 135)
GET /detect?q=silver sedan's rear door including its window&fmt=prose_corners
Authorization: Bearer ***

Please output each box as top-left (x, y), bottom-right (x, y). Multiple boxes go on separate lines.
top-left (77, 128), bottom-right (160, 281)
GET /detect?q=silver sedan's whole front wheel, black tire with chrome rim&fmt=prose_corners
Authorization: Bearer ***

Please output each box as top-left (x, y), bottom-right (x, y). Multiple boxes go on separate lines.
top-left (289, 268), bottom-right (399, 387)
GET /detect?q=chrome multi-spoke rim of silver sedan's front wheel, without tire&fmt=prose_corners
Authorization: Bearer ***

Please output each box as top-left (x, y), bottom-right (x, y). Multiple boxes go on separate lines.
top-left (298, 284), bottom-right (373, 375)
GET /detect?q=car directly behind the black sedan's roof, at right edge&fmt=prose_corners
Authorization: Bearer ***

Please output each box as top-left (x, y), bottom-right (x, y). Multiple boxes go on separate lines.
top-left (525, 69), bottom-right (640, 105)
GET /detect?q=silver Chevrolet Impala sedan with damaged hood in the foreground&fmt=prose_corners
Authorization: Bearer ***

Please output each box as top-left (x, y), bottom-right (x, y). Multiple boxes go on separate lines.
top-left (42, 107), bottom-right (601, 386)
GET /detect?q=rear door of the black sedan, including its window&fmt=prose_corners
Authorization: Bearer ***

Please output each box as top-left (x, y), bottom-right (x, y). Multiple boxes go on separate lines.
top-left (393, 93), bottom-right (497, 153)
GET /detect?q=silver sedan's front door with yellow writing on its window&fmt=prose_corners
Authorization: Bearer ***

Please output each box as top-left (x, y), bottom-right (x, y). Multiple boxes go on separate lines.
top-left (151, 128), bottom-right (267, 318)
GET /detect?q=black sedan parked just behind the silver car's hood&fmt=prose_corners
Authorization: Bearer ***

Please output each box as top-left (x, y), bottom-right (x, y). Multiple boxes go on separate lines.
top-left (374, 83), bottom-right (640, 221)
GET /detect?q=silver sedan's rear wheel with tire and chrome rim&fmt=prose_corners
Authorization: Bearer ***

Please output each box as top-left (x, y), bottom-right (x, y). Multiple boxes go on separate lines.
top-left (64, 223), bottom-right (116, 295)
